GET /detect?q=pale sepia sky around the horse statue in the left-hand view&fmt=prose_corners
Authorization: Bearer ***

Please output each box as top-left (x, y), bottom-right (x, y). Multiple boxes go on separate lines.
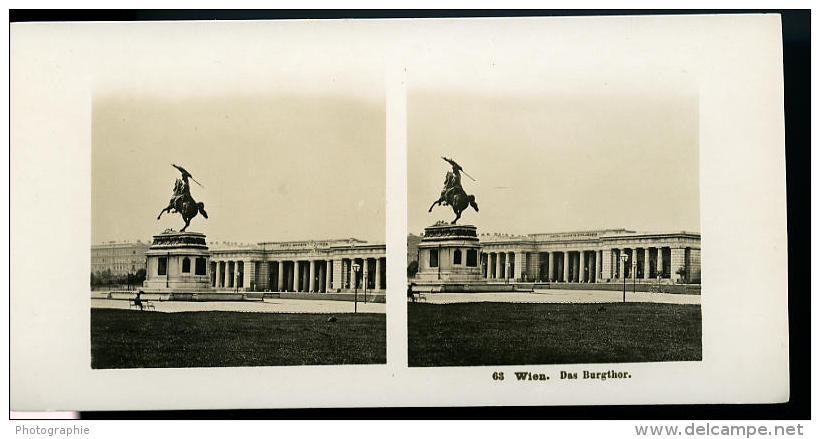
top-left (91, 94), bottom-right (385, 243)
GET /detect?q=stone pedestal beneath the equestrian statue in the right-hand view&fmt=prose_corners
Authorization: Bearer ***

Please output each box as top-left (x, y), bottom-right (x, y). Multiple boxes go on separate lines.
top-left (414, 223), bottom-right (483, 284)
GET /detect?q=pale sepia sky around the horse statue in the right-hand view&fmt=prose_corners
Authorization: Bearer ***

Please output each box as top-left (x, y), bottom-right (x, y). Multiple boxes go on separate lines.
top-left (407, 87), bottom-right (700, 234)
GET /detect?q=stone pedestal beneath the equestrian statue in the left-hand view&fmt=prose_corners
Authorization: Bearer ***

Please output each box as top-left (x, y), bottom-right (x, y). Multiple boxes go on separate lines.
top-left (143, 230), bottom-right (211, 292)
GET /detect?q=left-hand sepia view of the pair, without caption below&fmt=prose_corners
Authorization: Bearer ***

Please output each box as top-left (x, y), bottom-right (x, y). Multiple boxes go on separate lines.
top-left (90, 87), bottom-right (387, 369)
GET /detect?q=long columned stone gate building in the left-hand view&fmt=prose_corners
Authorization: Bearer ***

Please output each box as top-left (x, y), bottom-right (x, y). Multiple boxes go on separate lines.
top-left (208, 238), bottom-right (387, 293)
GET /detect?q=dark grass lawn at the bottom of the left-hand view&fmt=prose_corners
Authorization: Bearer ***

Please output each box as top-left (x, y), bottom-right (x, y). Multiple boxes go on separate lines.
top-left (91, 309), bottom-right (387, 369)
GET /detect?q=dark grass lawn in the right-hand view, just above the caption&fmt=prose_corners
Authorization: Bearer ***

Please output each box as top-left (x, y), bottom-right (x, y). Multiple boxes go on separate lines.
top-left (407, 303), bottom-right (702, 366)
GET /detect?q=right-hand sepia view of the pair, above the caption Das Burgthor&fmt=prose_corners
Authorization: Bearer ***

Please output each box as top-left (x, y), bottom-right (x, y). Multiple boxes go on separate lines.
top-left (407, 86), bottom-right (702, 367)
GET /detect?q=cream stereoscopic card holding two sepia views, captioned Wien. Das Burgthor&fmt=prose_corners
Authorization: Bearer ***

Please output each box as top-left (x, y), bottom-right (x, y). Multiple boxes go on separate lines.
top-left (9, 14), bottom-right (793, 413)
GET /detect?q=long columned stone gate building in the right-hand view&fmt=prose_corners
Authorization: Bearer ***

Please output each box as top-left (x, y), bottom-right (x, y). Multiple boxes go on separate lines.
top-left (479, 229), bottom-right (700, 283)
